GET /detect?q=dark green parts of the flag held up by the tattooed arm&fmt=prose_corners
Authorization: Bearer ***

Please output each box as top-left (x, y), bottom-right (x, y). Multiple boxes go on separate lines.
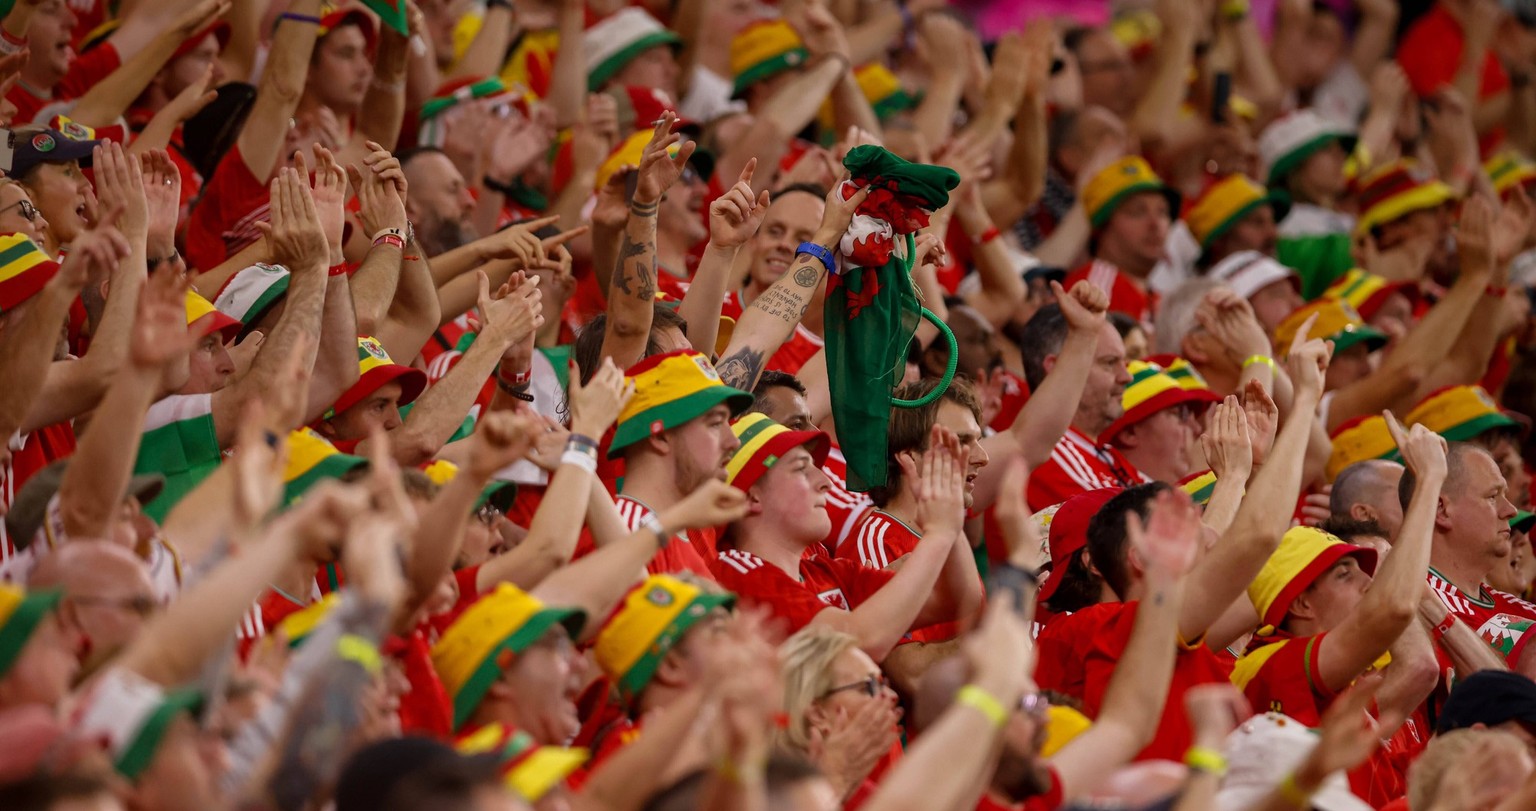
top-left (825, 144), bottom-right (960, 492)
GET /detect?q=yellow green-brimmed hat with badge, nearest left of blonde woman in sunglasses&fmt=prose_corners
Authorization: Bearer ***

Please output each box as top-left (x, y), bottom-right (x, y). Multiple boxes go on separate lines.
top-left (591, 574), bottom-right (736, 697)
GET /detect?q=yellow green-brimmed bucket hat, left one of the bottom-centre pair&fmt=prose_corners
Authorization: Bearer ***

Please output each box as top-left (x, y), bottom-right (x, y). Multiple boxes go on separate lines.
top-left (432, 584), bottom-right (587, 730)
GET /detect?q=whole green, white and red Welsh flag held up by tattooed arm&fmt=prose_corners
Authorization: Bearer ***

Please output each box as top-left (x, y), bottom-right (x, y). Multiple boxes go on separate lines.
top-left (825, 144), bottom-right (960, 492)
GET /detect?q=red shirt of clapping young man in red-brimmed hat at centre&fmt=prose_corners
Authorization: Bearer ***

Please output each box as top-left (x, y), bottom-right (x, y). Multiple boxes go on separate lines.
top-left (711, 547), bottom-right (894, 633)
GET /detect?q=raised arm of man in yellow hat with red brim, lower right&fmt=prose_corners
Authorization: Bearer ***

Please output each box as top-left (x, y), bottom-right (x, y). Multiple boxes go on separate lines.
top-left (1318, 412), bottom-right (1445, 691)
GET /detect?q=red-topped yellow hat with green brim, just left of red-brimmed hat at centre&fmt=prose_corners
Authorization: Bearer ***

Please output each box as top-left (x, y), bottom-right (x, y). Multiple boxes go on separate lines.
top-left (608, 349), bottom-right (753, 459)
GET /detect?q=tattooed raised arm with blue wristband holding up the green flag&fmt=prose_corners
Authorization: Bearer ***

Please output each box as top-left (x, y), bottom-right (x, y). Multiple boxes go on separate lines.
top-left (715, 179), bottom-right (869, 392)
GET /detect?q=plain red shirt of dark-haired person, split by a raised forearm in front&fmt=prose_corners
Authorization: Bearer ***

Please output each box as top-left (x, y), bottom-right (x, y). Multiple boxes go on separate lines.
top-left (1074, 602), bottom-right (1229, 760)
